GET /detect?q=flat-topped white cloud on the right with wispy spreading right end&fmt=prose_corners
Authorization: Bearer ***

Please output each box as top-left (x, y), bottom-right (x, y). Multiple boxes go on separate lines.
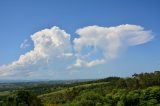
top-left (70, 24), bottom-right (153, 68)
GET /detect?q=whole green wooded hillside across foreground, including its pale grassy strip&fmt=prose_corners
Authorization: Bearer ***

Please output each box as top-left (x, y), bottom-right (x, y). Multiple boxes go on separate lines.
top-left (0, 71), bottom-right (160, 106)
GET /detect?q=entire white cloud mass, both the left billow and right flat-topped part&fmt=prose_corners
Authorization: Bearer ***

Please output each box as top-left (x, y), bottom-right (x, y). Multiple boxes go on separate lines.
top-left (0, 24), bottom-right (154, 76)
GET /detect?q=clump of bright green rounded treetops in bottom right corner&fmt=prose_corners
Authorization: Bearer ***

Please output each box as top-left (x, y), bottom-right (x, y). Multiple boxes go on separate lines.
top-left (106, 87), bottom-right (160, 106)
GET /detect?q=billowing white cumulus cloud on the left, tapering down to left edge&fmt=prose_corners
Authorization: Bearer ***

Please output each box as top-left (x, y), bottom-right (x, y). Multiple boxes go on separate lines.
top-left (0, 27), bottom-right (72, 76)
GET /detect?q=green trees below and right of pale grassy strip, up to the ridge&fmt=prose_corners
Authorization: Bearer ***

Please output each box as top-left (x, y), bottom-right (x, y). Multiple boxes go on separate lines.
top-left (41, 71), bottom-right (160, 106)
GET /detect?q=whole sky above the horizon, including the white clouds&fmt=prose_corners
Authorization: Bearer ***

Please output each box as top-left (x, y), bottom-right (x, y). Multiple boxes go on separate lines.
top-left (0, 0), bottom-right (160, 80)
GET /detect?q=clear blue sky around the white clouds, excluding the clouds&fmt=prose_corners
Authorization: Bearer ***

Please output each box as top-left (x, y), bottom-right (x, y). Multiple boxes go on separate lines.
top-left (0, 0), bottom-right (160, 79)
